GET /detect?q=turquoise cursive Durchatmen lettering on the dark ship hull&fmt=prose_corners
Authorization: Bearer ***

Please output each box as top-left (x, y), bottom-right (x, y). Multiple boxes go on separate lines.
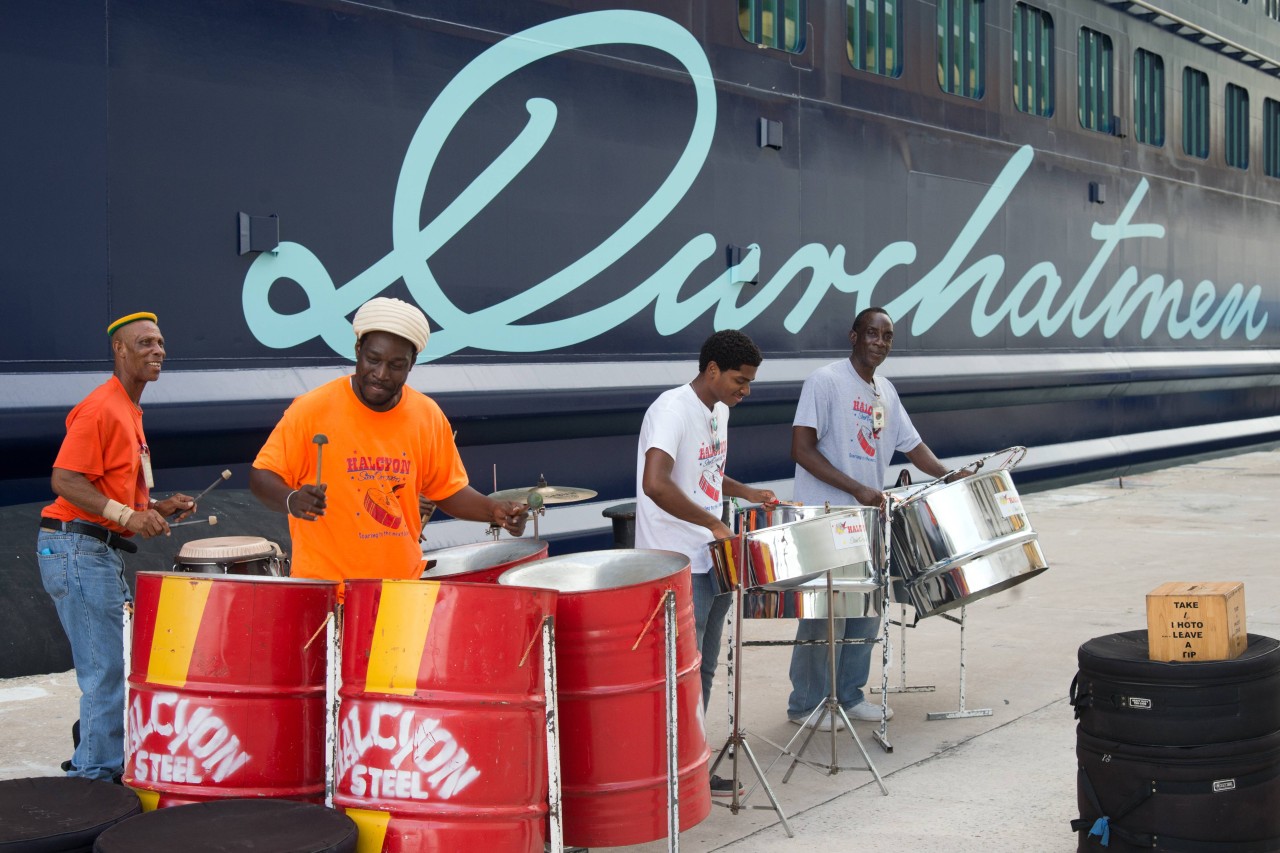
top-left (242, 10), bottom-right (1268, 361)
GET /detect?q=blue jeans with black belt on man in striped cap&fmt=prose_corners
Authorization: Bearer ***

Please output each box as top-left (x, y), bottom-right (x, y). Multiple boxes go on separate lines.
top-left (36, 530), bottom-right (133, 780)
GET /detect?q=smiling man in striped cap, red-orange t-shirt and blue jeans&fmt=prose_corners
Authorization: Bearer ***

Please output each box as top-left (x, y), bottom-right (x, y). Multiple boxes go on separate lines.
top-left (36, 313), bottom-right (196, 779)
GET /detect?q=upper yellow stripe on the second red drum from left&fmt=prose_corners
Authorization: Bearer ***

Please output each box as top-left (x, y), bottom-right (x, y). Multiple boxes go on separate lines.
top-left (365, 580), bottom-right (440, 695)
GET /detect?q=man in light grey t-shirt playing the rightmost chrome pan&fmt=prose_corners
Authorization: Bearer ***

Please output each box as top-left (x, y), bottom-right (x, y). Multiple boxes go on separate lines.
top-left (787, 307), bottom-right (962, 731)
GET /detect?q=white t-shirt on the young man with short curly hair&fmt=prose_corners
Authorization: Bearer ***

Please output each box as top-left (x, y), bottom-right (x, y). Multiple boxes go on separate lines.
top-left (636, 386), bottom-right (728, 574)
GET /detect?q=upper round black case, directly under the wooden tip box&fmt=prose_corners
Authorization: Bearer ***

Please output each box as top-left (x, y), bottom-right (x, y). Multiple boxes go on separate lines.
top-left (1071, 630), bottom-right (1280, 747)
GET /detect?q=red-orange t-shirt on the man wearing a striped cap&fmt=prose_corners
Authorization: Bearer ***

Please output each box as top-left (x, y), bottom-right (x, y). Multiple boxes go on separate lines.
top-left (41, 377), bottom-right (150, 535)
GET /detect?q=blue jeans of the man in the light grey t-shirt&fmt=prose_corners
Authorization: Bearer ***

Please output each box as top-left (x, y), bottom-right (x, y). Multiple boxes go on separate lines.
top-left (787, 616), bottom-right (879, 720)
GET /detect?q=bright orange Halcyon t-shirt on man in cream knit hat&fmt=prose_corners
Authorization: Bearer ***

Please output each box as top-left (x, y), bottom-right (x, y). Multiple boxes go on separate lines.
top-left (253, 377), bottom-right (467, 580)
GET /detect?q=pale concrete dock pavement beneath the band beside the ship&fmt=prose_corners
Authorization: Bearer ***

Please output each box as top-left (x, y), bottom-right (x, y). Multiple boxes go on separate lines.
top-left (0, 451), bottom-right (1280, 853)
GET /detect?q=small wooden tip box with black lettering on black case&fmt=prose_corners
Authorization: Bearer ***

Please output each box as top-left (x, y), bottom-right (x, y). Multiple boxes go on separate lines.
top-left (1147, 580), bottom-right (1249, 661)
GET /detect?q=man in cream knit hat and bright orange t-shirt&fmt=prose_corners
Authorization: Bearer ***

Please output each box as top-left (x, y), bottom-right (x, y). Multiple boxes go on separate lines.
top-left (250, 297), bottom-right (527, 580)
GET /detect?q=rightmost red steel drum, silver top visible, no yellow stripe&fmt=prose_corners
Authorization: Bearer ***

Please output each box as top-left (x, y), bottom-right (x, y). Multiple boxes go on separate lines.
top-left (499, 549), bottom-right (712, 848)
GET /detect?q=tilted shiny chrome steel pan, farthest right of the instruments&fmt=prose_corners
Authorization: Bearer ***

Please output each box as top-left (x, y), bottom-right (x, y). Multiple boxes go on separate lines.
top-left (890, 470), bottom-right (1048, 617)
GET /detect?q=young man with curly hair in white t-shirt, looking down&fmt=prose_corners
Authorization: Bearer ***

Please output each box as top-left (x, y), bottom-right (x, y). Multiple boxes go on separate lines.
top-left (636, 329), bottom-right (778, 794)
